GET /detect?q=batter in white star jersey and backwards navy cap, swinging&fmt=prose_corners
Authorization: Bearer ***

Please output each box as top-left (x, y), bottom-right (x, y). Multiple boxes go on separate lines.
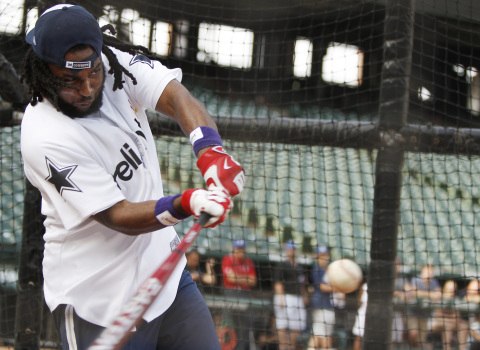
top-left (21, 4), bottom-right (244, 350)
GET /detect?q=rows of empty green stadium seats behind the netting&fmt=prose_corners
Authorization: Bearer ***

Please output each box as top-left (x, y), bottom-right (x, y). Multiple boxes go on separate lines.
top-left (0, 88), bottom-right (480, 279)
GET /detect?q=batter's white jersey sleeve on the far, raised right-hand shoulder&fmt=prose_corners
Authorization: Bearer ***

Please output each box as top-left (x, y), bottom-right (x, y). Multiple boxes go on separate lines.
top-left (113, 49), bottom-right (182, 109)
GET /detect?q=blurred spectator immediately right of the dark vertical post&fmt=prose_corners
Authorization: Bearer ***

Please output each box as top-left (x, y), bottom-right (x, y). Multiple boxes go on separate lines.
top-left (392, 258), bottom-right (411, 344)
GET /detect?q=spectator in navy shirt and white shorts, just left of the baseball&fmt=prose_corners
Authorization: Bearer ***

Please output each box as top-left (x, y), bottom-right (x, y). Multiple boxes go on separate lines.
top-left (308, 246), bottom-right (335, 350)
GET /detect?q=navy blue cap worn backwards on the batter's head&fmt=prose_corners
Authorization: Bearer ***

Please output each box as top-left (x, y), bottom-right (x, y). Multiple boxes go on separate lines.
top-left (25, 4), bottom-right (103, 69)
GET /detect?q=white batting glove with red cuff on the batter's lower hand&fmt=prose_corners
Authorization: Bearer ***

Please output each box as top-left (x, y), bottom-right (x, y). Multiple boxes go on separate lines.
top-left (182, 186), bottom-right (232, 227)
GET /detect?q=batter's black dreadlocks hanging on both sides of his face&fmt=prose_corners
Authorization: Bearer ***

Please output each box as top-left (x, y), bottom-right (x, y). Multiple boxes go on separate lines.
top-left (20, 24), bottom-right (158, 110)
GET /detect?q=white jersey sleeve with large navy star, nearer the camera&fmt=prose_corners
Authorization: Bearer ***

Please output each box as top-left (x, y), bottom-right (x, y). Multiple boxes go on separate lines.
top-left (21, 107), bottom-right (125, 230)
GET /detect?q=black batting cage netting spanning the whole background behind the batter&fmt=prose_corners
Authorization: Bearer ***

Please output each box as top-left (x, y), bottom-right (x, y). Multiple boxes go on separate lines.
top-left (0, 0), bottom-right (480, 350)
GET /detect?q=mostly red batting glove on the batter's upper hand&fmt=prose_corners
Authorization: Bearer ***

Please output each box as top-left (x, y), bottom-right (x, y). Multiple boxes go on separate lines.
top-left (197, 146), bottom-right (245, 197)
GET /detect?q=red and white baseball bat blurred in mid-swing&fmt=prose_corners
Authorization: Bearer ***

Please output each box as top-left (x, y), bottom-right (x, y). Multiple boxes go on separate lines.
top-left (88, 212), bottom-right (211, 350)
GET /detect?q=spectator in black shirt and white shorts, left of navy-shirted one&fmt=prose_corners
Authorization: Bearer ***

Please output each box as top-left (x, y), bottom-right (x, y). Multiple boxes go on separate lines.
top-left (273, 240), bottom-right (308, 350)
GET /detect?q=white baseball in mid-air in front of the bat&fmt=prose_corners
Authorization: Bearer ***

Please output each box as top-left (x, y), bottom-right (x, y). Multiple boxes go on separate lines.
top-left (326, 259), bottom-right (363, 294)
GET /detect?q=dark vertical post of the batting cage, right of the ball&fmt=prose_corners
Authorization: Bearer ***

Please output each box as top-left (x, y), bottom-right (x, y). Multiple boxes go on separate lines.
top-left (363, 0), bottom-right (415, 350)
